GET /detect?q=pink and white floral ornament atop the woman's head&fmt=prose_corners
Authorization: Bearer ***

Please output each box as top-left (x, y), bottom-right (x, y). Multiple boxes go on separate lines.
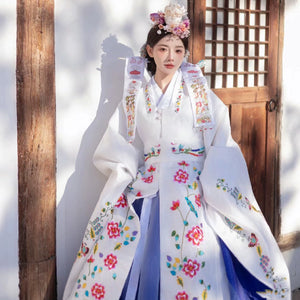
top-left (150, 4), bottom-right (190, 39)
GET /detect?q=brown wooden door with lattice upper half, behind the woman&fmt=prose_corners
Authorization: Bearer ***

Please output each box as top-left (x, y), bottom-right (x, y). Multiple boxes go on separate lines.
top-left (188, 0), bottom-right (279, 233)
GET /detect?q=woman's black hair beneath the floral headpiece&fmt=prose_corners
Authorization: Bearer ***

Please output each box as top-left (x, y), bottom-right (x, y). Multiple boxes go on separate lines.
top-left (145, 25), bottom-right (189, 75)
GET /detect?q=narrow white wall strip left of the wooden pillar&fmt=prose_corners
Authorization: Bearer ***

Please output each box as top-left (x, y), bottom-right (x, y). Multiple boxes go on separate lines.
top-left (0, 0), bottom-right (19, 300)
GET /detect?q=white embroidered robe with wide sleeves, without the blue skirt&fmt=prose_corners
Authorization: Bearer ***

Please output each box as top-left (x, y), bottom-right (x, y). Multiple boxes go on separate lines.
top-left (64, 59), bottom-right (290, 300)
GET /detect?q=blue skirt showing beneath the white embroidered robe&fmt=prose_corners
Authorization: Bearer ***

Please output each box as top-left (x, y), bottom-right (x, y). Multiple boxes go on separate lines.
top-left (120, 194), bottom-right (268, 300)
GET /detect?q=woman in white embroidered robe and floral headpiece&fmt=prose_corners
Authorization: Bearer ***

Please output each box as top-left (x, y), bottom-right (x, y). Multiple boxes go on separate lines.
top-left (64, 4), bottom-right (290, 300)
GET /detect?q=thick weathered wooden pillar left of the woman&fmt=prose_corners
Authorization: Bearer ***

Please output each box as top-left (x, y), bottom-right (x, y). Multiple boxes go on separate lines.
top-left (16, 0), bottom-right (56, 300)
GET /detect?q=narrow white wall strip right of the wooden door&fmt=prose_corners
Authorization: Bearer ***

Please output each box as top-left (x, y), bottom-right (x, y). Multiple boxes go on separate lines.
top-left (280, 0), bottom-right (300, 289)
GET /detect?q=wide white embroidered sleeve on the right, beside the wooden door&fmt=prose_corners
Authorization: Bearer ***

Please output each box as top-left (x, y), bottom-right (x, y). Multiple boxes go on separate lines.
top-left (200, 92), bottom-right (290, 299)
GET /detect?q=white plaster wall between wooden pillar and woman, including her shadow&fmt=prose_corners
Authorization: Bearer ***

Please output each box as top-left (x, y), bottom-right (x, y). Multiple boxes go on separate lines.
top-left (55, 0), bottom-right (186, 299)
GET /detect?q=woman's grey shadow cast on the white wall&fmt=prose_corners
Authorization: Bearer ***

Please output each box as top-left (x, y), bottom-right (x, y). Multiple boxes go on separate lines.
top-left (57, 35), bottom-right (133, 299)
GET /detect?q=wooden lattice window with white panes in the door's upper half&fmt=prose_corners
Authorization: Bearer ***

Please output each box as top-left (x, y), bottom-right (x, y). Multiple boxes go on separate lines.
top-left (205, 0), bottom-right (269, 88)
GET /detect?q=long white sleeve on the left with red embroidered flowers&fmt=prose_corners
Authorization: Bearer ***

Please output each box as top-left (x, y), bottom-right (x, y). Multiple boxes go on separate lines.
top-left (63, 103), bottom-right (141, 300)
